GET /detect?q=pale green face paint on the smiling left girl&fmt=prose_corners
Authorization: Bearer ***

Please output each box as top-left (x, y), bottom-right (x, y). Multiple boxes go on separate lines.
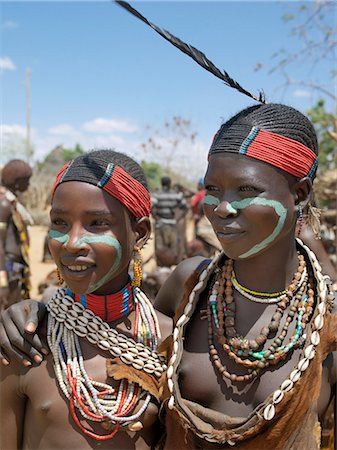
top-left (48, 230), bottom-right (122, 294)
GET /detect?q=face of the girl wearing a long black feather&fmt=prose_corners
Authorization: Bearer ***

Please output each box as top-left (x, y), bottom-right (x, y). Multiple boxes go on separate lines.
top-left (204, 153), bottom-right (297, 259)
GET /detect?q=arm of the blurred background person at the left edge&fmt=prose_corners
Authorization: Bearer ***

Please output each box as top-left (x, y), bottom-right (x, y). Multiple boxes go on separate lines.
top-left (0, 197), bottom-right (11, 309)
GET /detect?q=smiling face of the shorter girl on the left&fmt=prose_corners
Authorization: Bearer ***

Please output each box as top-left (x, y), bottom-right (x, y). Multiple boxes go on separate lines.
top-left (48, 181), bottom-right (150, 294)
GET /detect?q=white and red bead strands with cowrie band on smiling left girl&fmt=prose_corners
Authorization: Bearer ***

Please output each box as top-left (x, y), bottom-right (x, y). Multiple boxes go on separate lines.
top-left (47, 288), bottom-right (166, 440)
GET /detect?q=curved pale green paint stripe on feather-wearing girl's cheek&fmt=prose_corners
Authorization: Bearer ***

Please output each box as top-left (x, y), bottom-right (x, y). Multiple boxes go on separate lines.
top-left (231, 197), bottom-right (287, 258)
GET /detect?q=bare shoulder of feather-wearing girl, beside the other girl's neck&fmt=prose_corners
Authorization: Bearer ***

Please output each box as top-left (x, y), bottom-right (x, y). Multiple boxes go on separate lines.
top-left (154, 256), bottom-right (205, 317)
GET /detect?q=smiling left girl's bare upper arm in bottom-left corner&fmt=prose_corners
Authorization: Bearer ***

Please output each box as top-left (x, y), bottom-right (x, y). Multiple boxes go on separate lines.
top-left (0, 364), bottom-right (27, 450)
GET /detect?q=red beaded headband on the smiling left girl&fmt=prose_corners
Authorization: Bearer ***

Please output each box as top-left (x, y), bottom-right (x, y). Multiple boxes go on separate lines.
top-left (53, 161), bottom-right (151, 218)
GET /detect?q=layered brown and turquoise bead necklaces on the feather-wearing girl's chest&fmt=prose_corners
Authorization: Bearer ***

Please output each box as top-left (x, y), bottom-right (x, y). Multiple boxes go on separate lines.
top-left (208, 255), bottom-right (314, 382)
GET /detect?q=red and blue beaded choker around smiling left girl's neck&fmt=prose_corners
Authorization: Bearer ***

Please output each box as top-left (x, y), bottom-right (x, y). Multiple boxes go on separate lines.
top-left (67, 278), bottom-right (134, 322)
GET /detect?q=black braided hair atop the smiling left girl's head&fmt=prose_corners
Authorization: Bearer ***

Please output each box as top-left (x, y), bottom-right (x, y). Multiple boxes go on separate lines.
top-left (61, 150), bottom-right (149, 190)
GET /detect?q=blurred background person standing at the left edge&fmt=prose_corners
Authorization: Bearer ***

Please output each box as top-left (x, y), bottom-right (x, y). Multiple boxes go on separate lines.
top-left (0, 159), bottom-right (33, 309)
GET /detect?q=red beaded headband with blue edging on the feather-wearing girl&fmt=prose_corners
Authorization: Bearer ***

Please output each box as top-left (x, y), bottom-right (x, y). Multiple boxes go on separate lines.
top-left (210, 127), bottom-right (318, 178)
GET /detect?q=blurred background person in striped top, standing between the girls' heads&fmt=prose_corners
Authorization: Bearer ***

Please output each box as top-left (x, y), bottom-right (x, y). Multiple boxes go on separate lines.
top-left (151, 177), bottom-right (187, 267)
